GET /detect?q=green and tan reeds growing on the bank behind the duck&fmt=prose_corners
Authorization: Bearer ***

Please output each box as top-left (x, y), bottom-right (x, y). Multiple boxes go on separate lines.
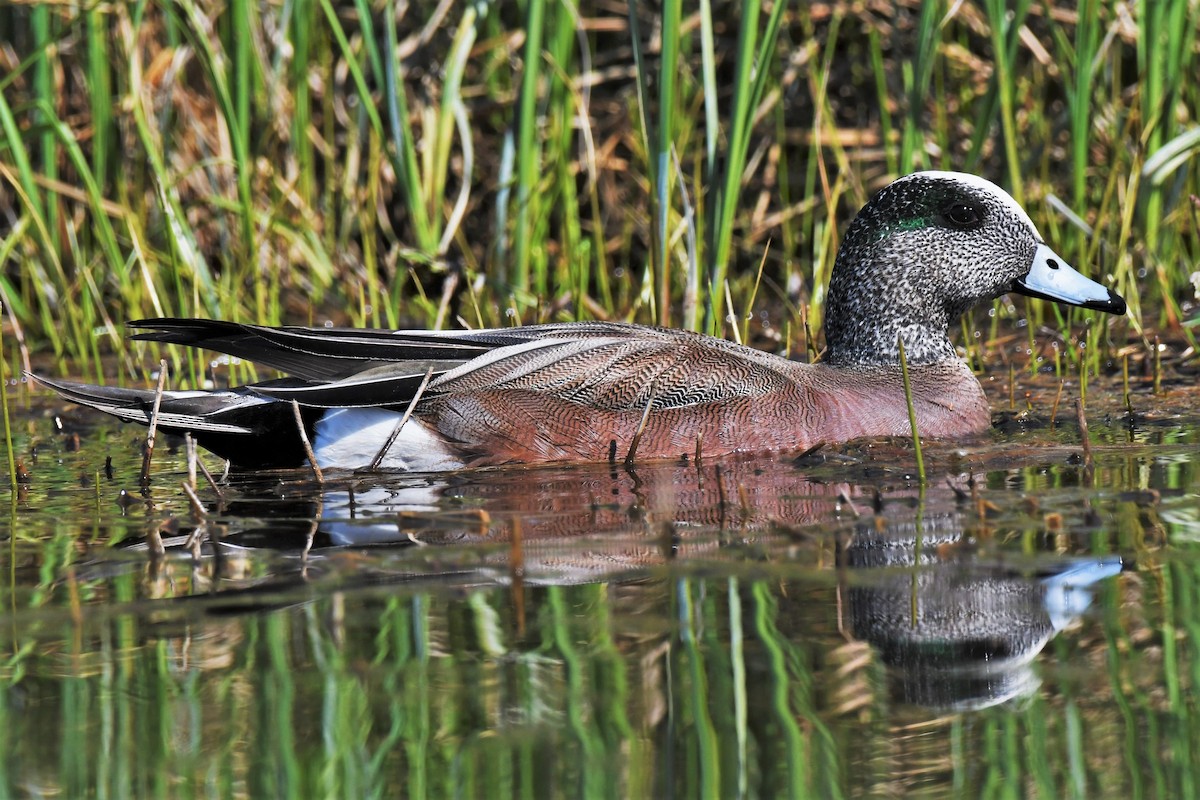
top-left (0, 0), bottom-right (1200, 374)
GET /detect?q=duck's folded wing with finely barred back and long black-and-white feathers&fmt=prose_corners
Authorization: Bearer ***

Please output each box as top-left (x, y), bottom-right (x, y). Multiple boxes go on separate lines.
top-left (132, 319), bottom-right (786, 410)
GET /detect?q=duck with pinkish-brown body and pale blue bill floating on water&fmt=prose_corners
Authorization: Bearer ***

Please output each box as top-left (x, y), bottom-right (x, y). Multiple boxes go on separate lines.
top-left (32, 172), bottom-right (1126, 471)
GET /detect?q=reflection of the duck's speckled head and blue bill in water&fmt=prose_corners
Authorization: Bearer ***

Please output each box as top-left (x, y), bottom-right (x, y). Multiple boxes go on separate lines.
top-left (845, 527), bottom-right (1122, 709)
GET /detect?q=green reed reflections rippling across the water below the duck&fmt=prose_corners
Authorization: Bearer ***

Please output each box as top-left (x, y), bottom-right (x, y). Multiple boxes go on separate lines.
top-left (0, 433), bottom-right (1200, 798)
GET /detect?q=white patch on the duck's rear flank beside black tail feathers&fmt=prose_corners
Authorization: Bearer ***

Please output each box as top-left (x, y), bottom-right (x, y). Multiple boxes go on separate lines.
top-left (312, 408), bottom-right (463, 473)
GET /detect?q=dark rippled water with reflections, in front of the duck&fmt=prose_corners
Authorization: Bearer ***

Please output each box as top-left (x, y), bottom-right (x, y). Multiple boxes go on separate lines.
top-left (0, 371), bottom-right (1200, 798)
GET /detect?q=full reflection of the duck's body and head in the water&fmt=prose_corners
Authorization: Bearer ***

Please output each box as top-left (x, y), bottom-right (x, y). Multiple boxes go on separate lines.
top-left (208, 453), bottom-right (1121, 709)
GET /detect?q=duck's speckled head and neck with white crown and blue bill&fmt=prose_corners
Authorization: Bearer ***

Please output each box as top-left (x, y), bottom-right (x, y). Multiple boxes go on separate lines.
top-left (826, 172), bottom-right (1126, 365)
